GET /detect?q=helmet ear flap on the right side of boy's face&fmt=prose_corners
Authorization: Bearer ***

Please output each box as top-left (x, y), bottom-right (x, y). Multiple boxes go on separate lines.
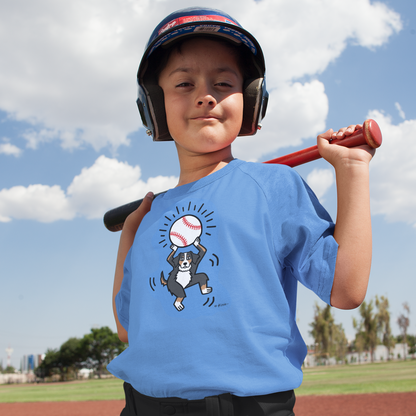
top-left (239, 78), bottom-right (269, 136)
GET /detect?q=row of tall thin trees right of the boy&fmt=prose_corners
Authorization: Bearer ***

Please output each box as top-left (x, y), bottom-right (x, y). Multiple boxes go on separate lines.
top-left (309, 296), bottom-right (416, 362)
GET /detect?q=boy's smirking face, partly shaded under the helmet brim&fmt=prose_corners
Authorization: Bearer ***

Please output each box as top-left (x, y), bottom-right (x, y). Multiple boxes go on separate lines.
top-left (159, 38), bottom-right (243, 158)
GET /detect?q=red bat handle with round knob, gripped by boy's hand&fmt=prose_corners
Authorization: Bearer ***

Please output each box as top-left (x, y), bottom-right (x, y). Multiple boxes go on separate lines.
top-left (264, 119), bottom-right (382, 168)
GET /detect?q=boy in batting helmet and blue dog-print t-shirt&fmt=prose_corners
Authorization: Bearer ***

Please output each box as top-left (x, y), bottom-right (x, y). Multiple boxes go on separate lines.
top-left (108, 8), bottom-right (374, 416)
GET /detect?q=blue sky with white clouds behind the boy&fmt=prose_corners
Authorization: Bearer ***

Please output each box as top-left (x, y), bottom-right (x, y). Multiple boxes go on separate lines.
top-left (0, 0), bottom-right (416, 368)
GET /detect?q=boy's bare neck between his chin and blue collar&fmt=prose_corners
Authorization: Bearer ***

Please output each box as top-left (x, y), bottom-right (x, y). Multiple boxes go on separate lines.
top-left (177, 146), bottom-right (234, 186)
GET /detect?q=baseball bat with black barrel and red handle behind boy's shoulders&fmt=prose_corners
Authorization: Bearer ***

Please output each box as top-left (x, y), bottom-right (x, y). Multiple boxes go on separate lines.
top-left (104, 119), bottom-right (382, 231)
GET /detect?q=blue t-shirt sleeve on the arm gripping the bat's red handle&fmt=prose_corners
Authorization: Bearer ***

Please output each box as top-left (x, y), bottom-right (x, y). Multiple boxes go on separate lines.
top-left (266, 170), bottom-right (338, 304)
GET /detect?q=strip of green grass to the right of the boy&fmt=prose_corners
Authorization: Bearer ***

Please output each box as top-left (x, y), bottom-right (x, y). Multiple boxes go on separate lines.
top-left (296, 360), bottom-right (416, 396)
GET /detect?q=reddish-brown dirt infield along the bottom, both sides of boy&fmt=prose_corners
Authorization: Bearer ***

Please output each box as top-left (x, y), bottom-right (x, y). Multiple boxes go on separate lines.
top-left (0, 392), bottom-right (416, 416)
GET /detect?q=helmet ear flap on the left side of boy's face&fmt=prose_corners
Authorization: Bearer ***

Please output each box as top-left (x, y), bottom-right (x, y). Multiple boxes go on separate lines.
top-left (137, 83), bottom-right (173, 142)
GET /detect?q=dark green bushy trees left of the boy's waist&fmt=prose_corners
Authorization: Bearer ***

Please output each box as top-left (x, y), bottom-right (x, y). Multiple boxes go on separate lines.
top-left (35, 326), bottom-right (127, 381)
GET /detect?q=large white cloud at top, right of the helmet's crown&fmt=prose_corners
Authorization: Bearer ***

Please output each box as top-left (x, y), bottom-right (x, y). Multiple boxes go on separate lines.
top-left (245, 0), bottom-right (402, 85)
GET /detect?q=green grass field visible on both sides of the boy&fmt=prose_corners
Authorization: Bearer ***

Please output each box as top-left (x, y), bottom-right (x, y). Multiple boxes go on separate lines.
top-left (0, 360), bottom-right (416, 403)
